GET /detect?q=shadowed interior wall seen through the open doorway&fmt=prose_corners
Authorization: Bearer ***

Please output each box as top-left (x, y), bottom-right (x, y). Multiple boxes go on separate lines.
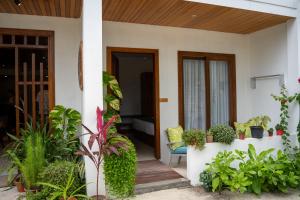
top-left (119, 56), bottom-right (153, 115)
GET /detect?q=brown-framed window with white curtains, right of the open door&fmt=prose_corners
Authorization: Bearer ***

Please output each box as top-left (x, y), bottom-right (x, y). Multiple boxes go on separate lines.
top-left (178, 52), bottom-right (236, 130)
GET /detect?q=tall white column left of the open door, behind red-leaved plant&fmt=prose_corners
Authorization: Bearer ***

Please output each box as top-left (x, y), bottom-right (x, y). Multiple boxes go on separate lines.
top-left (82, 0), bottom-right (105, 196)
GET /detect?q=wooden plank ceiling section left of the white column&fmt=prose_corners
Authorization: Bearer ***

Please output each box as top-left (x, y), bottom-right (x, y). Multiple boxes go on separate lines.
top-left (0, 0), bottom-right (82, 18)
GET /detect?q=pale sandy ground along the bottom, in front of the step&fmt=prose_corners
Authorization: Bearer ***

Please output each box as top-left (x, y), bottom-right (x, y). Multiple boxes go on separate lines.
top-left (0, 188), bottom-right (300, 200)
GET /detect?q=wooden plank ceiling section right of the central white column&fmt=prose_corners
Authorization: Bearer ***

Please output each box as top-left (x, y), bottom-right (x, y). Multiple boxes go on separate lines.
top-left (103, 0), bottom-right (290, 34)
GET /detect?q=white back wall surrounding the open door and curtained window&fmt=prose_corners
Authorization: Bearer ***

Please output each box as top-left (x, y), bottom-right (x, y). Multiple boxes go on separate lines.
top-left (103, 21), bottom-right (251, 162)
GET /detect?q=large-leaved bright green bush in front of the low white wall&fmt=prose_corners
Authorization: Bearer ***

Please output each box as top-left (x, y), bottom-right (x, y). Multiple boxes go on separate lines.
top-left (207, 144), bottom-right (300, 195)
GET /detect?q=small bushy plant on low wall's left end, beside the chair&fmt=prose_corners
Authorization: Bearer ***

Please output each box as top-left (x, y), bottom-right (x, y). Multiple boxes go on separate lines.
top-left (182, 129), bottom-right (205, 149)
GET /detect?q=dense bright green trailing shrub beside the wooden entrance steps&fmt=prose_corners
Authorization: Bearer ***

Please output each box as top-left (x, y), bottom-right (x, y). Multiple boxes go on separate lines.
top-left (104, 140), bottom-right (136, 198)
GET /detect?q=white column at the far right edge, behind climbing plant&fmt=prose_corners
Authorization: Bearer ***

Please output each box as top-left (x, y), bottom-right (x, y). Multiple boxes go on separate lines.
top-left (284, 10), bottom-right (300, 134)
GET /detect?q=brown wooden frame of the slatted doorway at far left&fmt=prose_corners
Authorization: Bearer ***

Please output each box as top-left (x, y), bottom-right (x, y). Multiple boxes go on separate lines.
top-left (0, 27), bottom-right (55, 136)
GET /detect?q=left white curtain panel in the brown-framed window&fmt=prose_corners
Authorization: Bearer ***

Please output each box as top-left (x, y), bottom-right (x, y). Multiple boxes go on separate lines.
top-left (183, 59), bottom-right (206, 130)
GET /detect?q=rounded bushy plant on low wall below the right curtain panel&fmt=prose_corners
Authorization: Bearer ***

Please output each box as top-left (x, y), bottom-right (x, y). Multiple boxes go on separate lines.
top-left (209, 125), bottom-right (235, 144)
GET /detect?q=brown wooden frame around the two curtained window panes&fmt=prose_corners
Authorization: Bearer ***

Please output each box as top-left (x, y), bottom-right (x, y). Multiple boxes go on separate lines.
top-left (178, 51), bottom-right (237, 130)
